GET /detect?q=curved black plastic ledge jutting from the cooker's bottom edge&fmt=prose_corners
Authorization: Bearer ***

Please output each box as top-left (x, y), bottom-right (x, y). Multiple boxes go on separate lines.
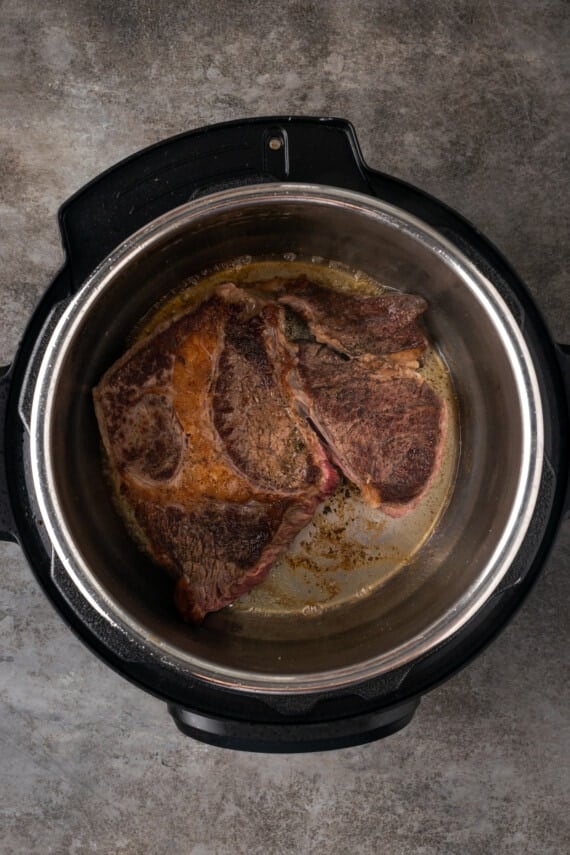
top-left (168, 698), bottom-right (419, 754)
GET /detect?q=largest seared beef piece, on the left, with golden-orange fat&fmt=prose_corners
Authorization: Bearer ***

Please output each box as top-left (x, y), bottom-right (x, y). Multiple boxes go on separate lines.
top-left (94, 285), bottom-right (338, 620)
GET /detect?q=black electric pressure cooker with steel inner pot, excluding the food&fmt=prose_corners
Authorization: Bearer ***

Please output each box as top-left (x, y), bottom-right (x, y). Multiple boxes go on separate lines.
top-left (0, 117), bottom-right (570, 751)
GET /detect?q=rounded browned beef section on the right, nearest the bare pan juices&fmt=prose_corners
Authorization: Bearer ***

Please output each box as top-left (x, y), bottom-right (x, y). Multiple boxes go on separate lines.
top-left (290, 343), bottom-right (446, 517)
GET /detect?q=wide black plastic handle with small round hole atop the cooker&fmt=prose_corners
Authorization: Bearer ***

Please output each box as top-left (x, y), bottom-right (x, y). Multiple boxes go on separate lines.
top-left (59, 116), bottom-right (370, 288)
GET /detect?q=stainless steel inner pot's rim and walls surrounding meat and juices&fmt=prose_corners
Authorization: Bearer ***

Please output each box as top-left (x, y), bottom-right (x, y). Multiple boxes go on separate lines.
top-left (28, 184), bottom-right (543, 693)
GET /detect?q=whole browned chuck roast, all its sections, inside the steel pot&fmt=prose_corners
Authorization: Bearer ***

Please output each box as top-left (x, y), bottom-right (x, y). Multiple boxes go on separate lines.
top-left (94, 277), bottom-right (446, 620)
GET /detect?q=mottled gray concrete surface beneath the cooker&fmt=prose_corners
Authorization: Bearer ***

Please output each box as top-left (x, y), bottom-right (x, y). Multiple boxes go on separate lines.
top-left (0, 0), bottom-right (570, 855)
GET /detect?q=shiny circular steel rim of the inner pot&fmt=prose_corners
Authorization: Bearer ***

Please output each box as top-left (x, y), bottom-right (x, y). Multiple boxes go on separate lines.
top-left (26, 183), bottom-right (544, 694)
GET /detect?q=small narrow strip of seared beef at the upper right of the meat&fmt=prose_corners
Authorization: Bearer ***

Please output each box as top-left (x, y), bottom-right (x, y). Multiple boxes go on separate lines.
top-left (279, 277), bottom-right (427, 367)
